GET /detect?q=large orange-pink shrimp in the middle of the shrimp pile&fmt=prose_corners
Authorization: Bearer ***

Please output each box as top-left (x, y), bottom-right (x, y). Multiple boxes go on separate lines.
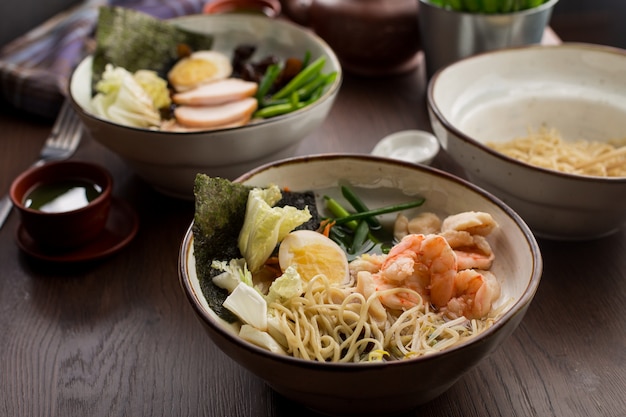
top-left (364, 234), bottom-right (457, 310)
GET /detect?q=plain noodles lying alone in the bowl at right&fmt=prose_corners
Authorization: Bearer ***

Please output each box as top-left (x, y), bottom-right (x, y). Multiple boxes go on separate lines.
top-left (487, 128), bottom-right (626, 177)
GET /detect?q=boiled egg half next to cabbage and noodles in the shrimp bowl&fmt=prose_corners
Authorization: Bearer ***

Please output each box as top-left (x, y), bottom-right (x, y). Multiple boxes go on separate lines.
top-left (278, 230), bottom-right (350, 284)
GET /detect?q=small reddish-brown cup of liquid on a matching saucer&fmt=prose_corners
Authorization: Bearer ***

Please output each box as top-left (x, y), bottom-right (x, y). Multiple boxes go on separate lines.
top-left (10, 161), bottom-right (113, 249)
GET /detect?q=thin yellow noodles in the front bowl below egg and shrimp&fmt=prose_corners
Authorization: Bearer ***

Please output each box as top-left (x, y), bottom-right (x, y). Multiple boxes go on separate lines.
top-left (269, 275), bottom-right (503, 362)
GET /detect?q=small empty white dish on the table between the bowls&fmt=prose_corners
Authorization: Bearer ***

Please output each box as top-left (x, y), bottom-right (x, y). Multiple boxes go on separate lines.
top-left (372, 130), bottom-right (439, 165)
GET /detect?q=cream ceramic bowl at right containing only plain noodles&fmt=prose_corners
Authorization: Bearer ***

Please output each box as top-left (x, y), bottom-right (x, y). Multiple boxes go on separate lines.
top-left (428, 44), bottom-right (626, 240)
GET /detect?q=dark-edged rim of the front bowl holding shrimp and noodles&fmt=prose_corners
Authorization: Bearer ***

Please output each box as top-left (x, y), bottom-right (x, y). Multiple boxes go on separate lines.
top-left (178, 153), bottom-right (543, 372)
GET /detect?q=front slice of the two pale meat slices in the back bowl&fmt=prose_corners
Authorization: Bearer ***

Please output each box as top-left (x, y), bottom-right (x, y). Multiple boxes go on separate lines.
top-left (174, 97), bottom-right (257, 128)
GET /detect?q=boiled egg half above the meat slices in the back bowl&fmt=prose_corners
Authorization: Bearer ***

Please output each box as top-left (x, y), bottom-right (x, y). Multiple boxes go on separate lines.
top-left (167, 51), bottom-right (233, 92)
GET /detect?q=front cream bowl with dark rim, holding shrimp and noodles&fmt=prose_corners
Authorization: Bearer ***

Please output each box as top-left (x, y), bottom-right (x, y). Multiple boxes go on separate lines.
top-left (179, 155), bottom-right (543, 416)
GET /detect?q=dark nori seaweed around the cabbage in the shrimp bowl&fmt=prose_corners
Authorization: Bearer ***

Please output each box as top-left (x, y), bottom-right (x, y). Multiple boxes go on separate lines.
top-left (192, 174), bottom-right (321, 322)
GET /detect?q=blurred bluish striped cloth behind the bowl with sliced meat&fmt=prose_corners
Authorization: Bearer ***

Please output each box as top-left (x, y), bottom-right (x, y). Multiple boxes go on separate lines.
top-left (0, 0), bottom-right (207, 118)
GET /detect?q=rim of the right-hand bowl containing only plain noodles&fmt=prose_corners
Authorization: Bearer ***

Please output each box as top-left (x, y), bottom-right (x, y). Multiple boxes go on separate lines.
top-left (426, 42), bottom-right (626, 184)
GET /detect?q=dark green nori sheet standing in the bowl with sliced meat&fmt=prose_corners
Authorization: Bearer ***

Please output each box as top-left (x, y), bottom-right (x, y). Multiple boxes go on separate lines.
top-left (92, 6), bottom-right (213, 86)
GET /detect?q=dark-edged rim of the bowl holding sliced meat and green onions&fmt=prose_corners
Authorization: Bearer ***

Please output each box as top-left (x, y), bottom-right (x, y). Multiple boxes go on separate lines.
top-left (67, 13), bottom-right (344, 136)
